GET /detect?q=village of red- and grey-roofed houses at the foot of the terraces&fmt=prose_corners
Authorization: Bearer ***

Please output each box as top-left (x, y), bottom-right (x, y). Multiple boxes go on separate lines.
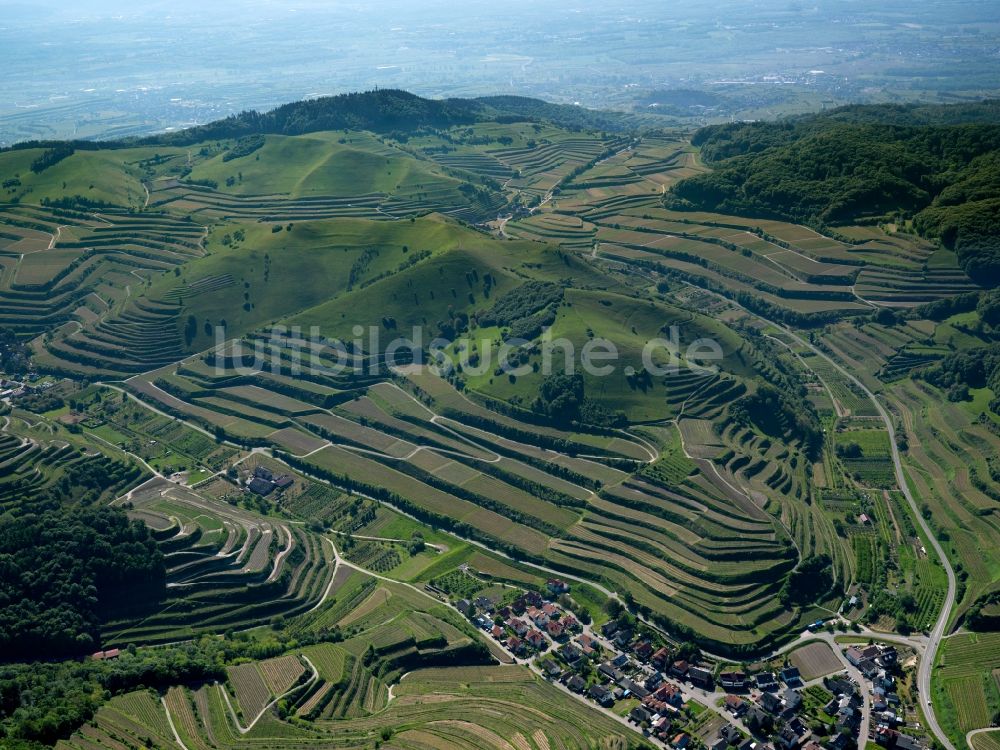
top-left (452, 578), bottom-right (927, 750)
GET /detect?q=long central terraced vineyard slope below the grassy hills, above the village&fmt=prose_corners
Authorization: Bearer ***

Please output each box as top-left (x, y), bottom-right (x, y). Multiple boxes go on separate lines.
top-left (103, 318), bottom-right (812, 645)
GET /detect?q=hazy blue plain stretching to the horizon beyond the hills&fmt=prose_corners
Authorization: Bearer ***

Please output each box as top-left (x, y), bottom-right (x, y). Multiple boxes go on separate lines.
top-left (0, 0), bottom-right (1000, 145)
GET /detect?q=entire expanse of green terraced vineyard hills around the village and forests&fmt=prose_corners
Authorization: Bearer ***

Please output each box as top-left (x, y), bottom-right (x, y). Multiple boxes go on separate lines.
top-left (0, 92), bottom-right (1000, 750)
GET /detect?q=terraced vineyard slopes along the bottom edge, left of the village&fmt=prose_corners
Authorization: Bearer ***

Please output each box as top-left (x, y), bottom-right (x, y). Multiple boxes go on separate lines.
top-left (57, 552), bottom-right (638, 750)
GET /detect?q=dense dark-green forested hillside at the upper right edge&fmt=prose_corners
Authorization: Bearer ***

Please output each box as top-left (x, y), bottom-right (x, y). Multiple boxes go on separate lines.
top-left (666, 102), bottom-right (1000, 286)
